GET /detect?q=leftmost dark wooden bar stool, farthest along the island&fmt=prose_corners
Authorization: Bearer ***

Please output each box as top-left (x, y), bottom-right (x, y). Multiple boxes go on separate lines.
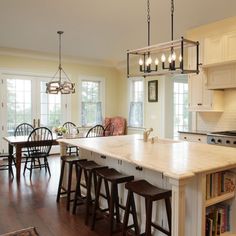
top-left (57, 156), bottom-right (87, 211)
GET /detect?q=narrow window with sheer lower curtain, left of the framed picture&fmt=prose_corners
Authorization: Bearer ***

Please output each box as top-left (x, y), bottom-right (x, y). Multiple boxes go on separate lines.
top-left (129, 78), bottom-right (144, 127)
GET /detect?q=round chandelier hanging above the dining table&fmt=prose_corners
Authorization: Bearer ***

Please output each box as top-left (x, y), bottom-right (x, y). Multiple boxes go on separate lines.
top-left (46, 31), bottom-right (75, 94)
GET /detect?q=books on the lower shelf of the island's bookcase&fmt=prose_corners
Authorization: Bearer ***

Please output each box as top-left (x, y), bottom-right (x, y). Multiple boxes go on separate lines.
top-left (205, 203), bottom-right (230, 236)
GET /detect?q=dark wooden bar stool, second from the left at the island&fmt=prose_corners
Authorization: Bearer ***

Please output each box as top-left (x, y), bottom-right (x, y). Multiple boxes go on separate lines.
top-left (73, 161), bottom-right (108, 225)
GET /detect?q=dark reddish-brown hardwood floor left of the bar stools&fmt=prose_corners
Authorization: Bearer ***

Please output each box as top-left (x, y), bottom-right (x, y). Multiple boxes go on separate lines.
top-left (0, 156), bottom-right (121, 236)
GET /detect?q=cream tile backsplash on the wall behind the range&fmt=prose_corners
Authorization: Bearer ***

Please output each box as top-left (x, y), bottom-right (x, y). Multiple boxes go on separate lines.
top-left (197, 89), bottom-right (236, 131)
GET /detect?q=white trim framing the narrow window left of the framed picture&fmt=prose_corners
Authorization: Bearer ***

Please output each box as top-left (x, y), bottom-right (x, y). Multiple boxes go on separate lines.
top-left (127, 77), bottom-right (146, 130)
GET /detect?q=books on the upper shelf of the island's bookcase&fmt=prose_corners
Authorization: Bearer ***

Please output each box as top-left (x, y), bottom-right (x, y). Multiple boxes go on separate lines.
top-left (206, 171), bottom-right (236, 199)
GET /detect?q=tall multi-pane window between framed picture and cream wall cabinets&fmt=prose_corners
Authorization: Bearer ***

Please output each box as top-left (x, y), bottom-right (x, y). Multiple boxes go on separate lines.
top-left (173, 78), bottom-right (190, 138)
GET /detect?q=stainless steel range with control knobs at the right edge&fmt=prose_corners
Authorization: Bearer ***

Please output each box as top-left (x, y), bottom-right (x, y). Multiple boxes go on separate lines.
top-left (207, 130), bottom-right (236, 147)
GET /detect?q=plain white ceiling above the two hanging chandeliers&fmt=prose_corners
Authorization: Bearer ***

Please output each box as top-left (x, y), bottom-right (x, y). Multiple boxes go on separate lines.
top-left (0, 0), bottom-right (236, 63)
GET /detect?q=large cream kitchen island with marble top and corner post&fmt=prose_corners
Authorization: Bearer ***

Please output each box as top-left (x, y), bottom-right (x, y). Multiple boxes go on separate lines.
top-left (59, 135), bottom-right (236, 236)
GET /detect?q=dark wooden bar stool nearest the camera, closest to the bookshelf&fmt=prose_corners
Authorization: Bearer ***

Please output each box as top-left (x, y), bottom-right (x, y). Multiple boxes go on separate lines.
top-left (123, 180), bottom-right (171, 236)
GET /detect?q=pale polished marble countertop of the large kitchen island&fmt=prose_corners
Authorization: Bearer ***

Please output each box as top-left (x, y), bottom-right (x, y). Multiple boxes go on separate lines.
top-left (58, 135), bottom-right (236, 179)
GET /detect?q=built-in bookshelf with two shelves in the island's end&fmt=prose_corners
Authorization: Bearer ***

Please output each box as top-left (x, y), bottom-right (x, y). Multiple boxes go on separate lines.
top-left (205, 170), bottom-right (236, 236)
